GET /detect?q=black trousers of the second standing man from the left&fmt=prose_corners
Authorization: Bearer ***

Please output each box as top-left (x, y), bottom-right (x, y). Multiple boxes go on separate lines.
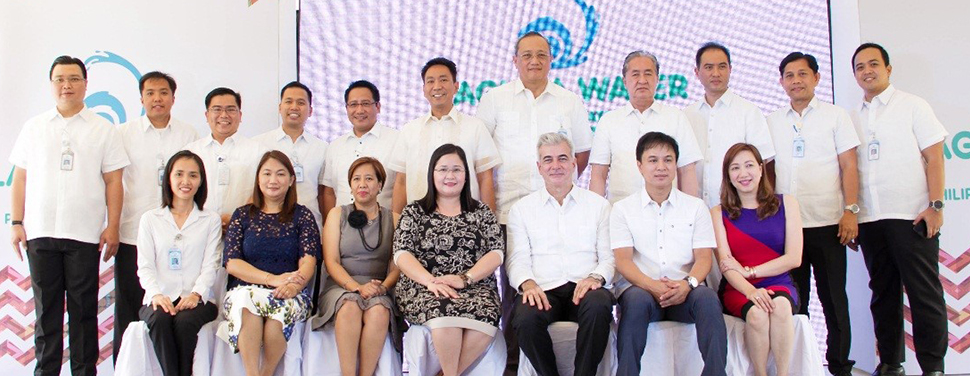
top-left (112, 243), bottom-right (145, 363)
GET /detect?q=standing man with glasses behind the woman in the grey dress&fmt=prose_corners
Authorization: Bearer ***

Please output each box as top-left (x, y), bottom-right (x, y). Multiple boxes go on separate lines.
top-left (323, 80), bottom-right (403, 213)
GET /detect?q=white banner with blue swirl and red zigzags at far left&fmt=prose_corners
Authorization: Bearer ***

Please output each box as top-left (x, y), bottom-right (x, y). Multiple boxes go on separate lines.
top-left (0, 0), bottom-right (296, 375)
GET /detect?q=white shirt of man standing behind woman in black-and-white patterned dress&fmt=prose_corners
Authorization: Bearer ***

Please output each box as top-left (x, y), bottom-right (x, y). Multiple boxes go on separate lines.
top-left (388, 108), bottom-right (502, 202)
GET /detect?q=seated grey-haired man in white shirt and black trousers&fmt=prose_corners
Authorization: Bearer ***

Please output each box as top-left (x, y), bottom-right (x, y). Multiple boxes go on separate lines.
top-left (507, 132), bottom-right (614, 376)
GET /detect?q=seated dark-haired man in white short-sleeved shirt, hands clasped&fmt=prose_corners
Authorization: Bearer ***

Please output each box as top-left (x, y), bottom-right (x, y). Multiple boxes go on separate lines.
top-left (610, 132), bottom-right (727, 376)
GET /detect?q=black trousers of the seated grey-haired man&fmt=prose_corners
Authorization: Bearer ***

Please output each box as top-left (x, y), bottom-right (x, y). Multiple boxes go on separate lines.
top-left (512, 282), bottom-right (616, 376)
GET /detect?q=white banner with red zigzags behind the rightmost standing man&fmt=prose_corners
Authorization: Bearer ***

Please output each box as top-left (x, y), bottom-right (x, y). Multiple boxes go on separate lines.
top-left (852, 0), bottom-right (970, 375)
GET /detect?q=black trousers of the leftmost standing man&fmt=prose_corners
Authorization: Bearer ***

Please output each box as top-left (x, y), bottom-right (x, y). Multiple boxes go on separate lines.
top-left (27, 238), bottom-right (101, 376)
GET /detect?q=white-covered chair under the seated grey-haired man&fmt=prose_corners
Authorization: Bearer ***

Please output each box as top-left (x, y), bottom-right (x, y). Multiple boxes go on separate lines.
top-left (518, 321), bottom-right (616, 376)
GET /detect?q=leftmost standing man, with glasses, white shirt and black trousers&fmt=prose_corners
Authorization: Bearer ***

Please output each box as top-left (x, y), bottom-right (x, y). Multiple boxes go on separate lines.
top-left (10, 56), bottom-right (128, 376)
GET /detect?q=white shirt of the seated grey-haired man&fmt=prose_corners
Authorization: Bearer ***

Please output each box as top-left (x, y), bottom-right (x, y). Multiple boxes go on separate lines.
top-left (506, 186), bottom-right (615, 291)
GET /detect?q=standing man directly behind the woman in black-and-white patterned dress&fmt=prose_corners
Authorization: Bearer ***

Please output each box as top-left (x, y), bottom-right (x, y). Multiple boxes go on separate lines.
top-left (388, 57), bottom-right (502, 214)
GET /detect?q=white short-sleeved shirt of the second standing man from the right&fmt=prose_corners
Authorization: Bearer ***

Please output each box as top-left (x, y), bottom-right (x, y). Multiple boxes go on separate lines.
top-left (768, 97), bottom-right (859, 228)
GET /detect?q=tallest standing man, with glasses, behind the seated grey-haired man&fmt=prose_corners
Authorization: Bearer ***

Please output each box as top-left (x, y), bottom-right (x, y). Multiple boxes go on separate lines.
top-left (477, 31), bottom-right (593, 373)
